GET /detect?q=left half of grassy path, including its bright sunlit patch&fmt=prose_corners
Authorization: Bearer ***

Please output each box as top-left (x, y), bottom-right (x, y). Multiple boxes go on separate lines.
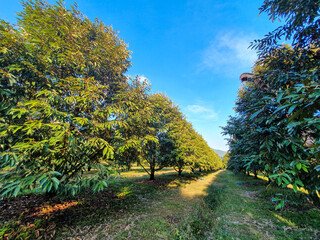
top-left (58, 171), bottom-right (221, 239)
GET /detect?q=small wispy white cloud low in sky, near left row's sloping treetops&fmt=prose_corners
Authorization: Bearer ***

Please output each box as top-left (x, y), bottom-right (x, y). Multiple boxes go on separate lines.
top-left (185, 104), bottom-right (218, 121)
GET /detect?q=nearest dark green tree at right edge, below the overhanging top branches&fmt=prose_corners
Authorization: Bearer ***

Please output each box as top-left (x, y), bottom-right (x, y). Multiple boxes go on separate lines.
top-left (250, 46), bottom-right (320, 204)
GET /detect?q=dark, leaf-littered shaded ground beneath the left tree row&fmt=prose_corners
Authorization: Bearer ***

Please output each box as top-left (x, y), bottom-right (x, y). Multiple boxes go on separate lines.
top-left (0, 172), bottom-right (216, 239)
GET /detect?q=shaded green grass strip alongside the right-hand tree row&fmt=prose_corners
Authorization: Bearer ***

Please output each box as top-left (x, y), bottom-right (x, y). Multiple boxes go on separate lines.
top-left (206, 171), bottom-right (320, 239)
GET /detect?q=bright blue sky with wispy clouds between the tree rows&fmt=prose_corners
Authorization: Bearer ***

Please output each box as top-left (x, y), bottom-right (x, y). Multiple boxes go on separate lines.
top-left (0, 0), bottom-right (279, 150)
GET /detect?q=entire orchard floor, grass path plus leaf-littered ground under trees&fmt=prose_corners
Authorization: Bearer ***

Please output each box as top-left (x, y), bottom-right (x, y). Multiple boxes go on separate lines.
top-left (0, 168), bottom-right (320, 240)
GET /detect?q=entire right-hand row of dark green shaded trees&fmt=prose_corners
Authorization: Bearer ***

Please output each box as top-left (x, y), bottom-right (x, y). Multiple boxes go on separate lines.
top-left (224, 0), bottom-right (320, 205)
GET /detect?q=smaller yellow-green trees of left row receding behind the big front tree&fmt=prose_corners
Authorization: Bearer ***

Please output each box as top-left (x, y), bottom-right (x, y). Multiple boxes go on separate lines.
top-left (115, 76), bottom-right (221, 180)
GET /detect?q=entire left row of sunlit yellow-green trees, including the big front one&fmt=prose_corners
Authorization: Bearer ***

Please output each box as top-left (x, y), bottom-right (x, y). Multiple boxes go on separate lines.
top-left (0, 0), bottom-right (221, 196)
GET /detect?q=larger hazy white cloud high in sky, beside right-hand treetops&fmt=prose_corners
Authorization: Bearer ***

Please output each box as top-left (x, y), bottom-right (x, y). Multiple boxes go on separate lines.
top-left (200, 31), bottom-right (257, 73)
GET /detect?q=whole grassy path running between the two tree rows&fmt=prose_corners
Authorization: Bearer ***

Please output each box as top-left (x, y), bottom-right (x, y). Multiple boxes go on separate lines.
top-left (58, 171), bottom-right (320, 240)
